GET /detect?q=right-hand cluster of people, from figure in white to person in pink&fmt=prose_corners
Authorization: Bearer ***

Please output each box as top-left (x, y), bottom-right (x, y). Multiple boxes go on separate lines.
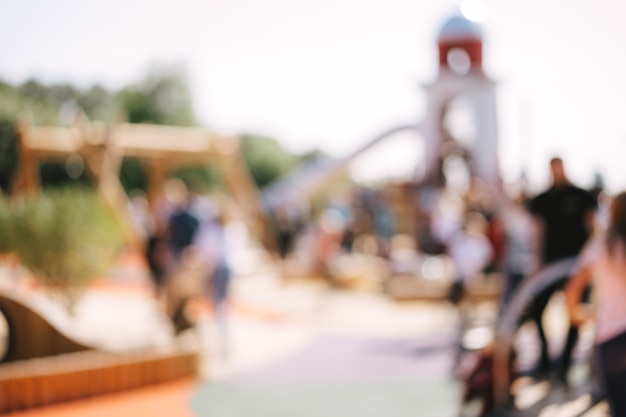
top-left (425, 158), bottom-right (626, 417)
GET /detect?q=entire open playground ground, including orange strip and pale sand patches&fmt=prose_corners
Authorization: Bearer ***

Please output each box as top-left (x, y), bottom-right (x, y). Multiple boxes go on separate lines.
top-left (0, 245), bottom-right (458, 417)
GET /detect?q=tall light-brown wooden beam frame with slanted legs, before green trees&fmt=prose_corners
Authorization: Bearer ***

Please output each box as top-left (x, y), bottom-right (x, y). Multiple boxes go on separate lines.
top-left (14, 114), bottom-right (265, 244)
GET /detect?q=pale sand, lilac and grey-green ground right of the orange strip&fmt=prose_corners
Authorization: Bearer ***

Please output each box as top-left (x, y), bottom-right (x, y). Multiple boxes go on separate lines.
top-left (192, 260), bottom-right (458, 417)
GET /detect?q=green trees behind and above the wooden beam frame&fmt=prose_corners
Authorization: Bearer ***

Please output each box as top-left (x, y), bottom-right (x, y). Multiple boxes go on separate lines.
top-left (0, 66), bottom-right (298, 191)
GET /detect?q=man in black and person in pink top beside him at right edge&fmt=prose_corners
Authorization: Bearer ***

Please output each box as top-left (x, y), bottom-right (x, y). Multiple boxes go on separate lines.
top-left (504, 158), bottom-right (626, 417)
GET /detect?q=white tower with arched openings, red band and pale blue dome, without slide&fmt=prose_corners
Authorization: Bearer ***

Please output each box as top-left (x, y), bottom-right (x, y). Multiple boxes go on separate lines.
top-left (422, 15), bottom-right (501, 189)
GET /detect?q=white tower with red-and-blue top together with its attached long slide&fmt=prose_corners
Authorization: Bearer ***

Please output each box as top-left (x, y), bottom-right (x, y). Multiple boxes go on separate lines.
top-left (263, 10), bottom-right (501, 207)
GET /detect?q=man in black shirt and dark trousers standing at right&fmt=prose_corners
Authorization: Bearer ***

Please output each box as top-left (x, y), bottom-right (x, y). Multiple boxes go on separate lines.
top-left (529, 158), bottom-right (597, 382)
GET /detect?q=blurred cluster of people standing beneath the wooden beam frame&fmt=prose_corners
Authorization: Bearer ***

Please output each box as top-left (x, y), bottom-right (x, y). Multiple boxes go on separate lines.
top-left (135, 180), bottom-right (231, 350)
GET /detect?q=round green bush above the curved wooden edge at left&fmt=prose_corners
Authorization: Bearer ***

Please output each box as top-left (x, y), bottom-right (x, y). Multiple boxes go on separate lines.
top-left (0, 188), bottom-right (123, 311)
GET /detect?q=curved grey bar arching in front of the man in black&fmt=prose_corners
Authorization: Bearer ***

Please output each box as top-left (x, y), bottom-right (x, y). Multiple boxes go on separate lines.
top-left (492, 256), bottom-right (577, 407)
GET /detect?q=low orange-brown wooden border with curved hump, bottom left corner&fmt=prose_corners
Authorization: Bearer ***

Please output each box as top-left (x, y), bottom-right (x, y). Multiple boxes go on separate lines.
top-left (0, 287), bottom-right (200, 414)
